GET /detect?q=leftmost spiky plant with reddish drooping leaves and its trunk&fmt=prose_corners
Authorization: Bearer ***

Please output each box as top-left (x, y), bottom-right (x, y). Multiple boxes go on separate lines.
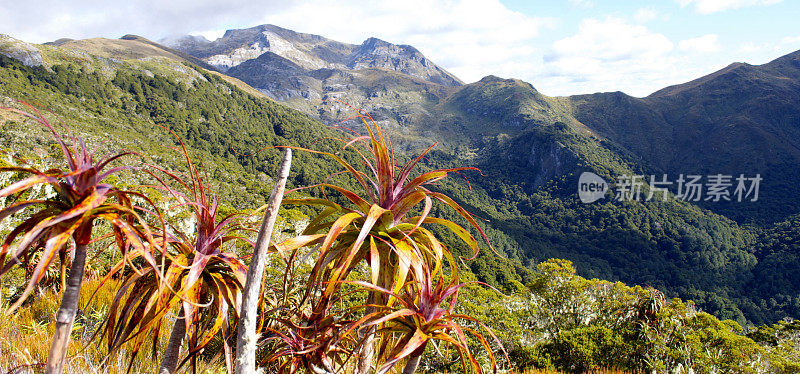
top-left (0, 103), bottom-right (158, 373)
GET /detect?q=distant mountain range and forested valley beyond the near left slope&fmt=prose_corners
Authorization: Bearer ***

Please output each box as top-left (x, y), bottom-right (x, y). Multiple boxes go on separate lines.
top-left (0, 25), bottom-right (800, 322)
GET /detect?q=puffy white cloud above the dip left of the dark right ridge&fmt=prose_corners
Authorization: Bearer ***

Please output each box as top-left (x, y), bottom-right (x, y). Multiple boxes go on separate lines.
top-left (531, 17), bottom-right (713, 96)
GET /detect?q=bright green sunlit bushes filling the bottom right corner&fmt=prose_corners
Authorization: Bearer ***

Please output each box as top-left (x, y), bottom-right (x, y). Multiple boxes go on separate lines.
top-left (456, 260), bottom-right (800, 373)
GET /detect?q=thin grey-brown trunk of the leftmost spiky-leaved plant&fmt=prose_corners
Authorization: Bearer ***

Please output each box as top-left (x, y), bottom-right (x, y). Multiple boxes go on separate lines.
top-left (45, 241), bottom-right (91, 374)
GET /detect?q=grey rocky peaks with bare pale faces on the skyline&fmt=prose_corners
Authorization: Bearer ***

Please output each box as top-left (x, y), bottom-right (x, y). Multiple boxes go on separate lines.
top-left (162, 25), bottom-right (462, 147)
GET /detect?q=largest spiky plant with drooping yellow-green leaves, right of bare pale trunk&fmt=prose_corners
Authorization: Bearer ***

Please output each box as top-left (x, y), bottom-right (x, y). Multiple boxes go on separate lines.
top-left (265, 109), bottom-right (504, 373)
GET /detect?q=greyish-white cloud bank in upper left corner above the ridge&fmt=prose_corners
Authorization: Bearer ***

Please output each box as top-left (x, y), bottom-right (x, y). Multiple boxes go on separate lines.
top-left (0, 0), bottom-right (291, 43)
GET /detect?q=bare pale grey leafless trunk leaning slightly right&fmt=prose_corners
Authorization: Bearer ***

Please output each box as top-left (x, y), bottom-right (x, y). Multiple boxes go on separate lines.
top-left (235, 148), bottom-right (292, 374)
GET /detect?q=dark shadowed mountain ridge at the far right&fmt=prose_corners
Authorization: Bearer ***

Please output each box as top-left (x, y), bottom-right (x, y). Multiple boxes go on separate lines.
top-left (570, 47), bottom-right (800, 223)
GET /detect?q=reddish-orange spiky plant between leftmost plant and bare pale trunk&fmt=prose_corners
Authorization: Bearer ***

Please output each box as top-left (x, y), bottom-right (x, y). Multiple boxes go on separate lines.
top-left (104, 134), bottom-right (252, 374)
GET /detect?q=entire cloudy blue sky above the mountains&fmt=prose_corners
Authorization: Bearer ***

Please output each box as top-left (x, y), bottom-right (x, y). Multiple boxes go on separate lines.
top-left (0, 0), bottom-right (800, 96)
